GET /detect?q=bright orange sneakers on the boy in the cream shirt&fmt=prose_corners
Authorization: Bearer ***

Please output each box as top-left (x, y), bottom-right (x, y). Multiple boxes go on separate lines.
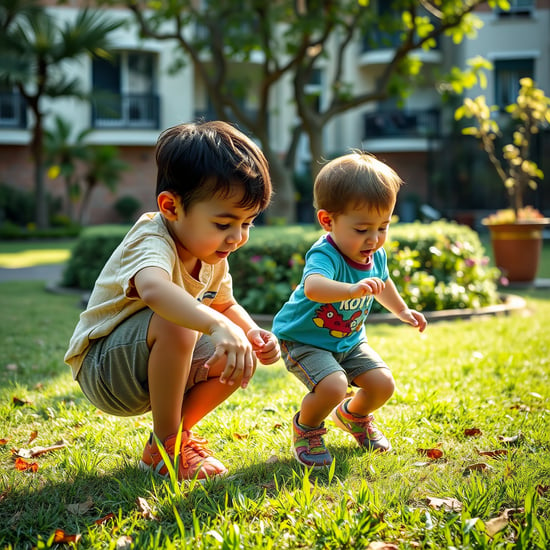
top-left (139, 430), bottom-right (231, 481)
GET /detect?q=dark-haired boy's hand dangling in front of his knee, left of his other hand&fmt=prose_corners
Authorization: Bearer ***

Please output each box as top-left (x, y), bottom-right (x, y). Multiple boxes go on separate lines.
top-left (206, 323), bottom-right (256, 388)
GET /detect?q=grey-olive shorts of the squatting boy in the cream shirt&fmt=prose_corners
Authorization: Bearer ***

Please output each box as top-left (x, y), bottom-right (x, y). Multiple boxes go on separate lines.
top-left (77, 308), bottom-right (214, 416)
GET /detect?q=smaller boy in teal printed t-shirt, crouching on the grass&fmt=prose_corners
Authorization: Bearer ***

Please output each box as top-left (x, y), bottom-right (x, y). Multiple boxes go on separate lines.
top-left (273, 152), bottom-right (427, 467)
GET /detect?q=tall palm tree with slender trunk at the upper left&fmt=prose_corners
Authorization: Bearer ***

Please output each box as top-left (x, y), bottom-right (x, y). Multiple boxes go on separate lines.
top-left (0, 0), bottom-right (121, 228)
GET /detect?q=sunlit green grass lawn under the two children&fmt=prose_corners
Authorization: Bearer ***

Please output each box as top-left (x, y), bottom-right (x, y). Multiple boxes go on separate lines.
top-left (0, 282), bottom-right (550, 549)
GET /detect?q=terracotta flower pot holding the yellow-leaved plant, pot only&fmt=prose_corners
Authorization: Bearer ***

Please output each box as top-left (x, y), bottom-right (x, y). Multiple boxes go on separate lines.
top-left (487, 218), bottom-right (550, 283)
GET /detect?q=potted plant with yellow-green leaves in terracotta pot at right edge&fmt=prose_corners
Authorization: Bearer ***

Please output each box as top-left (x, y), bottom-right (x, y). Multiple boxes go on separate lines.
top-left (455, 78), bottom-right (550, 282)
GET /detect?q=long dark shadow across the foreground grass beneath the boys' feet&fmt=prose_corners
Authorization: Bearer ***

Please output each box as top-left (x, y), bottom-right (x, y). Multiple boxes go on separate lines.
top-left (0, 448), bottom-right (358, 549)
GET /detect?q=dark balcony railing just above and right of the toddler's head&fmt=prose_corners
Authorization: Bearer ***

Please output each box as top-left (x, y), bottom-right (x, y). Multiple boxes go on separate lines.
top-left (363, 109), bottom-right (439, 139)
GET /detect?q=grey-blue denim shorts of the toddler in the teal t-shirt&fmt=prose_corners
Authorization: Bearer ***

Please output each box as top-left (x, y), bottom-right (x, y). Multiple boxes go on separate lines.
top-left (279, 340), bottom-right (389, 391)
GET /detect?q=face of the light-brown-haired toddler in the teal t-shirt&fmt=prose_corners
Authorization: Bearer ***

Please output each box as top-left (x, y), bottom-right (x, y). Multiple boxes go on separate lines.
top-left (317, 205), bottom-right (393, 265)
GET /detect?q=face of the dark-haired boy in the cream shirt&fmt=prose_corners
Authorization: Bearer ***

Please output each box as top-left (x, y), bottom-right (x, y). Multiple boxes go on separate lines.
top-left (165, 187), bottom-right (258, 267)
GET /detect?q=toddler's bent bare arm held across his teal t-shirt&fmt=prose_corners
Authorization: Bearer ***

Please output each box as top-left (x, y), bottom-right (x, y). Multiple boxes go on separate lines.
top-left (304, 273), bottom-right (384, 303)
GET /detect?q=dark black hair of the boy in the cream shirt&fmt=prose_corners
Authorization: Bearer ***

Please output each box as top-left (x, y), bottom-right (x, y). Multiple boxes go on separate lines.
top-left (156, 120), bottom-right (272, 211)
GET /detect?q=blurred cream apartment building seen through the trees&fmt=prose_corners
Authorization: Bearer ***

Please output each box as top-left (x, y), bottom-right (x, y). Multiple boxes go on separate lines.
top-left (0, 0), bottom-right (550, 224)
